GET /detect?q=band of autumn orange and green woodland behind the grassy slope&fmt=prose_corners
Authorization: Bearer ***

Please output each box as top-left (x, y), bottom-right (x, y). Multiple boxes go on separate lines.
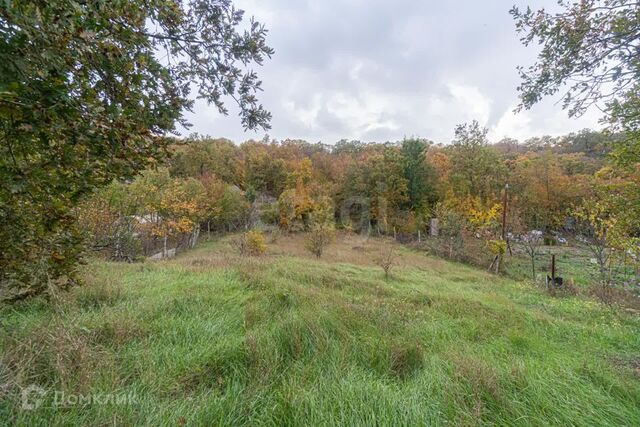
top-left (78, 122), bottom-right (640, 284)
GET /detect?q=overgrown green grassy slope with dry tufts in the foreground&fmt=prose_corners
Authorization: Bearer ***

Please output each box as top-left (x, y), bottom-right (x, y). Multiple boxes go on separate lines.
top-left (0, 236), bottom-right (640, 426)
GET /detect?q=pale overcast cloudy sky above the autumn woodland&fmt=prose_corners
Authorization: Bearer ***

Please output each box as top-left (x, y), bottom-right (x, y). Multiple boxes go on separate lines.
top-left (181, 0), bottom-right (599, 144)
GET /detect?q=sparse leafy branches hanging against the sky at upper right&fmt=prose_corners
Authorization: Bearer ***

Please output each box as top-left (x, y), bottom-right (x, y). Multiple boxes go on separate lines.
top-left (511, 0), bottom-right (640, 163)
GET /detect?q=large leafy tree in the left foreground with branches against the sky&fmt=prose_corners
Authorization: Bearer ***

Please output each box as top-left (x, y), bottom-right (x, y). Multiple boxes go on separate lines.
top-left (0, 0), bottom-right (273, 299)
